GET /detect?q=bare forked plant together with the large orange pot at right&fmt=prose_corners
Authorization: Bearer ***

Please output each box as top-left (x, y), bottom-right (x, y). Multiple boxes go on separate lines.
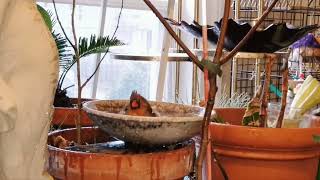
top-left (144, 0), bottom-right (320, 179)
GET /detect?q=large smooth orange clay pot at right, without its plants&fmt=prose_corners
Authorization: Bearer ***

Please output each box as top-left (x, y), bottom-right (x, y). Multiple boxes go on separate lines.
top-left (209, 109), bottom-right (320, 180)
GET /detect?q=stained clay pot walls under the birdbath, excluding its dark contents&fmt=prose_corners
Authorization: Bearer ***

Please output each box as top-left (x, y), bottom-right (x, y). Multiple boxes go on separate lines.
top-left (47, 128), bottom-right (195, 180)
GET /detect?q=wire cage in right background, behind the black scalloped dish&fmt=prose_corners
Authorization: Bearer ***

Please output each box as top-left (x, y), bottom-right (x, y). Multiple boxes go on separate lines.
top-left (231, 0), bottom-right (320, 101)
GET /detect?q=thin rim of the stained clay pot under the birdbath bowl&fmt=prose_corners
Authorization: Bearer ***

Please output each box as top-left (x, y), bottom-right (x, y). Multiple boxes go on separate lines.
top-left (48, 127), bottom-right (195, 158)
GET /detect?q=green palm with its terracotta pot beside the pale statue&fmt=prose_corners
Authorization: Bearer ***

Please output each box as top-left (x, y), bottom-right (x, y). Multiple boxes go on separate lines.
top-left (37, 5), bottom-right (123, 127)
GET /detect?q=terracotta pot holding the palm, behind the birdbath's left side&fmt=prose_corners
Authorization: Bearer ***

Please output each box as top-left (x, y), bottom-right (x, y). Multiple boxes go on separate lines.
top-left (51, 99), bottom-right (93, 128)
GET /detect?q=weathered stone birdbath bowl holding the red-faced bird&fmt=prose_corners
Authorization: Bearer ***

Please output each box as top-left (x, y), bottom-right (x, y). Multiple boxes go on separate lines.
top-left (83, 100), bottom-right (204, 146)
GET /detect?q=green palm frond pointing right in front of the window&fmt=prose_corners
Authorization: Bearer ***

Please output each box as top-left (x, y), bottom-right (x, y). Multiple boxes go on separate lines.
top-left (78, 35), bottom-right (124, 58)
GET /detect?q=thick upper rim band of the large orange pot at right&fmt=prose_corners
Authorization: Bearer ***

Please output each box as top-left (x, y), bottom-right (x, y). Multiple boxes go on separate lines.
top-left (209, 123), bottom-right (320, 149)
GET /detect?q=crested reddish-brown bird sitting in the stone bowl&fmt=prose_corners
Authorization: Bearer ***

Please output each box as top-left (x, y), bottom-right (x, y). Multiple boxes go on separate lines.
top-left (125, 91), bottom-right (156, 117)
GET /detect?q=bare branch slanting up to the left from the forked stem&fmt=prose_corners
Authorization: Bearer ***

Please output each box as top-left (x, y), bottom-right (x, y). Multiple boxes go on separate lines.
top-left (143, 0), bottom-right (203, 71)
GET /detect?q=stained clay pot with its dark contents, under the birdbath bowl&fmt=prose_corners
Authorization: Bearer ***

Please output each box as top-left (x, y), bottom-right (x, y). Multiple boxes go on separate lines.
top-left (48, 128), bottom-right (195, 180)
